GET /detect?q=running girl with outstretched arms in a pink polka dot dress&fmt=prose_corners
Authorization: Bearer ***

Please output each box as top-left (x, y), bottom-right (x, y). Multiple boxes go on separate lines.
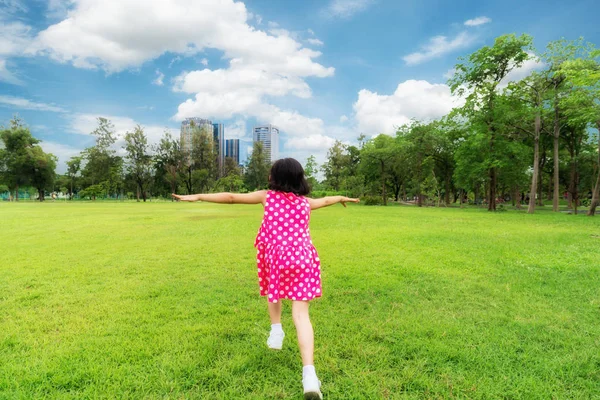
top-left (173, 158), bottom-right (359, 400)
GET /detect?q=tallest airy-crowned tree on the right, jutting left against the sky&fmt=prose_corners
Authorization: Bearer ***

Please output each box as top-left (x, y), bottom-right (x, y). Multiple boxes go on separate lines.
top-left (449, 34), bottom-right (532, 211)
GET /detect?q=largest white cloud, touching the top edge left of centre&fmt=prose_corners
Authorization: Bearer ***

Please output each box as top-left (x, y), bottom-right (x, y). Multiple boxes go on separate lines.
top-left (29, 0), bottom-right (333, 76)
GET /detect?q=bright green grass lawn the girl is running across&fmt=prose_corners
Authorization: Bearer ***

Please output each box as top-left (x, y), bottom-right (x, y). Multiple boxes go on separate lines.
top-left (0, 202), bottom-right (600, 400)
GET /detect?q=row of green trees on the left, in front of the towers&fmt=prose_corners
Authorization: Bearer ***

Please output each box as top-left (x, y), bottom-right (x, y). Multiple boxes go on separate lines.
top-left (0, 117), bottom-right (270, 201)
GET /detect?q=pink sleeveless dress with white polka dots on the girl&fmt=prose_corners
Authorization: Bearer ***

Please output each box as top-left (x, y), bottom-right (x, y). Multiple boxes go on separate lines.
top-left (254, 190), bottom-right (321, 303)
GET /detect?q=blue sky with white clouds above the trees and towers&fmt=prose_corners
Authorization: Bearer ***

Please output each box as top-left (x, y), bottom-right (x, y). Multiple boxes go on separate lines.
top-left (0, 0), bottom-right (600, 170)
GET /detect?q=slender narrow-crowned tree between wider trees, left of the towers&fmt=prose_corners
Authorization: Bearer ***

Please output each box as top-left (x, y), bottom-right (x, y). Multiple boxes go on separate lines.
top-left (123, 125), bottom-right (152, 202)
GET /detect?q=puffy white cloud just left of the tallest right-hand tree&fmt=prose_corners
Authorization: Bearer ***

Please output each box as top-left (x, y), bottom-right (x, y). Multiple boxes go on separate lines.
top-left (353, 80), bottom-right (461, 135)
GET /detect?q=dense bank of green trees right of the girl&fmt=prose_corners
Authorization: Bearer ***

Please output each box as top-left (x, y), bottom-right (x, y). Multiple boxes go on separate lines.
top-left (316, 35), bottom-right (600, 215)
